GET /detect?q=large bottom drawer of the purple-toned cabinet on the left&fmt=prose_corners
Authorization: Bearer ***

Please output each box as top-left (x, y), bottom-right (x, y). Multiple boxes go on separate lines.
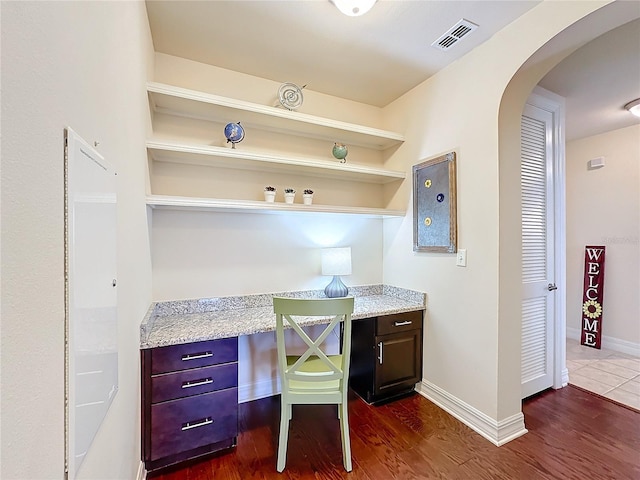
top-left (149, 388), bottom-right (238, 461)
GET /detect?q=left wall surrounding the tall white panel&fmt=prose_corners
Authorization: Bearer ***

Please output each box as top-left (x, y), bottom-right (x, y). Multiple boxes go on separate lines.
top-left (0, 1), bottom-right (153, 480)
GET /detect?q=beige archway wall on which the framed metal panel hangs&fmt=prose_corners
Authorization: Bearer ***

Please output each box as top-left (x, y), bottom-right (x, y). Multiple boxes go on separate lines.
top-left (383, 2), bottom-right (602, 421)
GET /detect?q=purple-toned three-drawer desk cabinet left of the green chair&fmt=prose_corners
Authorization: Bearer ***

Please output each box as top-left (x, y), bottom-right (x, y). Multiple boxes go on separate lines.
top-left (141, 337), bottom-right (238, 472)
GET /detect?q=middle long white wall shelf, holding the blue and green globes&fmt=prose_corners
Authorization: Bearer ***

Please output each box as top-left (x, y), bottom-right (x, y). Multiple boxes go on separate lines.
top-left (147, 141), bottom-right (406, 183)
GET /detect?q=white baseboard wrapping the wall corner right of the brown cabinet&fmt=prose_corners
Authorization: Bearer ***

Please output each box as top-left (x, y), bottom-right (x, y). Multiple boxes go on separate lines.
top-left (417, 380), bottom-right (527, 447)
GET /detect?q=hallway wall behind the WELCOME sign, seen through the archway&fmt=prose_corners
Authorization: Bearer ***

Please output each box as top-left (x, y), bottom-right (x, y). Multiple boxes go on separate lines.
top-left (567, 125), bottom-right (640, 354)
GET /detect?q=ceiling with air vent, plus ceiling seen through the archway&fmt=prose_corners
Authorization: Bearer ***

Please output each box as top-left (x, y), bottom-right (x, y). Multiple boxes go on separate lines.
top-left (146, 0), bottom-right (640, 139)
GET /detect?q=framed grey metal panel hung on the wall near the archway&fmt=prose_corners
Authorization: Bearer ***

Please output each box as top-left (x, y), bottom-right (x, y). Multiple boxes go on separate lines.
top-left (413, 152), bottom-right (457, 253)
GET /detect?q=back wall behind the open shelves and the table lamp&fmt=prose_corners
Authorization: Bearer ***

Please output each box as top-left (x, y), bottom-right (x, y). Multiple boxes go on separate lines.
top-left (151, 54), bottom-right (382, 301)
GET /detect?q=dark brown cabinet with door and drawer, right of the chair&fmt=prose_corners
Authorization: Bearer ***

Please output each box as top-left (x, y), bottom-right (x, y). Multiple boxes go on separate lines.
top-left (349, 310), bottom-right (423, 404)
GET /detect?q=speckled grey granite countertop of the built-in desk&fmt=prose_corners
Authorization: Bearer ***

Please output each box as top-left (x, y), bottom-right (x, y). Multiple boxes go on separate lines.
top-left (140, 285), bottom-right (426, 349)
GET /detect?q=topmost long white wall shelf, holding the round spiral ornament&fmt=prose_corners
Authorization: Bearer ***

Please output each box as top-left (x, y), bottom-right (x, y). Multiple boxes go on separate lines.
top-left (147, 82), bottom-right (404, 150)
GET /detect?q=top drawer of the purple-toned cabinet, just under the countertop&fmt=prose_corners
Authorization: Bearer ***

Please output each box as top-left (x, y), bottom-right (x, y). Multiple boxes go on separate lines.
top-left (151, 337), bottom-right (238, 374)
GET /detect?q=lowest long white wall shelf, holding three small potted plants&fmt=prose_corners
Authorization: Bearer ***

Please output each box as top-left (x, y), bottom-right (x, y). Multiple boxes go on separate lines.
top-left (147, 195), bottom-right (406, 218)
